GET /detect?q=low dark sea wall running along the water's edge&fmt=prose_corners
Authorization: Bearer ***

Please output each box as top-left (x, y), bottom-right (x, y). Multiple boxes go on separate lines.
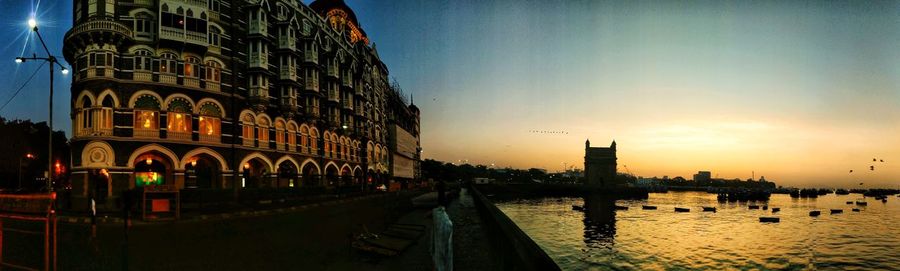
top-left (470, 186), bottom-right (560, 271)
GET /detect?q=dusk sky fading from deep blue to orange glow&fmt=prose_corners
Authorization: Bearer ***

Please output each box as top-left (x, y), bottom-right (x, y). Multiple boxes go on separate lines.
top-left (0, 0), bottom-right (900, 188)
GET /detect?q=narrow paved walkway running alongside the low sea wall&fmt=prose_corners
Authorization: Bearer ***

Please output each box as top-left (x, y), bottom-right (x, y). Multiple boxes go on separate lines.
top-left (447, 188), bottom-right (499, 270)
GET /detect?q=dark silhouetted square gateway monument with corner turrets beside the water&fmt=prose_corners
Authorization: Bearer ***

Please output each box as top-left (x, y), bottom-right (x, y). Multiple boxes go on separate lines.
top-left (584, 140), bottom-right (617, 186)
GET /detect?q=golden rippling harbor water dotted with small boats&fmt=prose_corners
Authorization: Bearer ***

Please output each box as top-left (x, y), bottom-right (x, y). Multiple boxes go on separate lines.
top-left (497, 192), bottom-right (900, 270)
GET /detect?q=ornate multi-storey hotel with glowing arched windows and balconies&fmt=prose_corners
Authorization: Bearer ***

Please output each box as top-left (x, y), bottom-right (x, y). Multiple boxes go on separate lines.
top-left (63, 0), bottom-right (421, 209)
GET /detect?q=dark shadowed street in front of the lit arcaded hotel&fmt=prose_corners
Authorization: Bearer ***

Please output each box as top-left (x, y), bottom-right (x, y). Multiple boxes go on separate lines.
top-left (53, 192), bottom-right (431, 270)
